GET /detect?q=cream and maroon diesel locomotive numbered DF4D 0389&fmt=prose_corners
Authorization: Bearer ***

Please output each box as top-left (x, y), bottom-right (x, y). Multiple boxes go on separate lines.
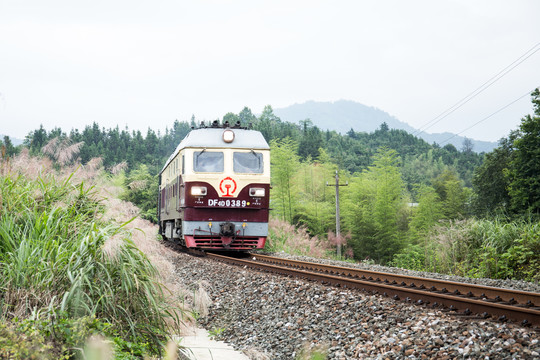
top-left (158, 121), bottom-right (270, 252)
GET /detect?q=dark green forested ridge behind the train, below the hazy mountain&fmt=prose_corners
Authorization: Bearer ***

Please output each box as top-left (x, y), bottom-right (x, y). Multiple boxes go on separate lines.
top-left (7, 105), bottom-right (482, 188)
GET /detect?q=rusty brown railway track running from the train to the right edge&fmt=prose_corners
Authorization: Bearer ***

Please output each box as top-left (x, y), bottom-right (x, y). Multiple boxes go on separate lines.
top-left (207, 253), bottom-right (540, 330)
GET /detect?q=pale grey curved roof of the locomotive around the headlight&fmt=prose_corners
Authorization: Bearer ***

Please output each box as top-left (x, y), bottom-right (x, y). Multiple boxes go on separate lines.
top-left (161, 128), bottom-right (270, 172)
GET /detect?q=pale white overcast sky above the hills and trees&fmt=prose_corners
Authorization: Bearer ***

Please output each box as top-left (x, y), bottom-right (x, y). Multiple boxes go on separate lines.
top-left (0, 0), bottom-right (540, 141)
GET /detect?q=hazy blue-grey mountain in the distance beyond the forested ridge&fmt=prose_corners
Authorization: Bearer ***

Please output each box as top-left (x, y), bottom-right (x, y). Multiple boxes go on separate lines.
top-left (274, 100), bottom-right (497, 153)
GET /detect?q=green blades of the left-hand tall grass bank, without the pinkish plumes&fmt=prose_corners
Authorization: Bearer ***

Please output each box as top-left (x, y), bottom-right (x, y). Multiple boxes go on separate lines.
top-left (0, 167), bottom-right (184, 353)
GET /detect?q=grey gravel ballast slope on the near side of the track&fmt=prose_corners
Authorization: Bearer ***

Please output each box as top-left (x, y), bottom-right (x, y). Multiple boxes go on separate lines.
top-left (175, 253), bottom-right (540, 359)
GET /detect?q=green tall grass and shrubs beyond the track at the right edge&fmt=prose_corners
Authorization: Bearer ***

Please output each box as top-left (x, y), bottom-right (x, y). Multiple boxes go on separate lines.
top-left (393, 217), bottom-right (540, 282)
